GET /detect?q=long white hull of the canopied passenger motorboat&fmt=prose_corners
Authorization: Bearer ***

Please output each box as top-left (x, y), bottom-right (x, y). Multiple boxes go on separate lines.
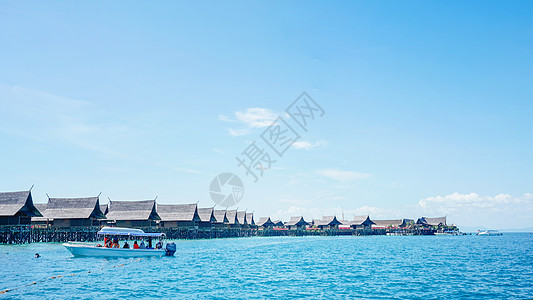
top-left (63, 243), bottom-right (166, 257)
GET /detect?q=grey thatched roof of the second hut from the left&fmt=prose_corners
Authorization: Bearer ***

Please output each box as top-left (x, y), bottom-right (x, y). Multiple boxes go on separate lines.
top-left (43, 197), bottom-right (105, 219)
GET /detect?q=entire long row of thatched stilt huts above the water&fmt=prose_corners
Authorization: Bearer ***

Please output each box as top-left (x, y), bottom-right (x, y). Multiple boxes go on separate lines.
top-left (0, 190), bottom-right (447, 229)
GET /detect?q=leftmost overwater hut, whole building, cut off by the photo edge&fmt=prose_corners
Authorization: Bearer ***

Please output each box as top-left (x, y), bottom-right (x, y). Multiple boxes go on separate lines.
top-left (0, 190), bottom-right (42, 225)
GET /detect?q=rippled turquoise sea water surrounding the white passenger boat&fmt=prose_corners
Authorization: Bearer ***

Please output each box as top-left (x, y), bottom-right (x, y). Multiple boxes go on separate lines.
top-left (0, 233), bottom-right (533, 299)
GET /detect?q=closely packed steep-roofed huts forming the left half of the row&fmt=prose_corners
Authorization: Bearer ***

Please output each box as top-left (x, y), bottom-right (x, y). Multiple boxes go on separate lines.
top-left (0, 191), bottom-right (255, 228)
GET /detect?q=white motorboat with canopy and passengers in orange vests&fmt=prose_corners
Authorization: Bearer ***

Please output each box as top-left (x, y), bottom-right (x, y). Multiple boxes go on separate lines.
top-left (63, 227), bottom-right (176, 257)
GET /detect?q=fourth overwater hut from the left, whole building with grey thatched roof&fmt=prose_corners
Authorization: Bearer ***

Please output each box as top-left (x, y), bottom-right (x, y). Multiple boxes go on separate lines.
top-left (157, 203), bottom-right (201, 228)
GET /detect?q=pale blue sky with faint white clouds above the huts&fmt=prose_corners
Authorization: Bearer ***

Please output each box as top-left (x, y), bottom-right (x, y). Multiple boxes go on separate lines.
top-left (0, 1), bottom-right (533, 228)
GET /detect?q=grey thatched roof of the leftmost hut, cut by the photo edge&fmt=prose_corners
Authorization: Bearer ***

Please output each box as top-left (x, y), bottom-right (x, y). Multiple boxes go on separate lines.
top-left (0, 191), bottom-right (41, 217)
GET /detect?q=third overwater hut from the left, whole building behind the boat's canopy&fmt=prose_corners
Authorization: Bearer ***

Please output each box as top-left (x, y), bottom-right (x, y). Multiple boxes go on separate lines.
top-left (106, 199), bottom-right (161, 227)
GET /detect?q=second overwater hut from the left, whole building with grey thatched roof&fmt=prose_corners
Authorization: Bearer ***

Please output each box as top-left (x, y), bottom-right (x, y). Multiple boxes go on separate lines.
top-left (35, 197), bottom-right (106, 227)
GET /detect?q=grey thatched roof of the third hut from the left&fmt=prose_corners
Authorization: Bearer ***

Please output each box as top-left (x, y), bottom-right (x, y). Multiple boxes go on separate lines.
top-left (106, 200), bottom-right (161, 221)
